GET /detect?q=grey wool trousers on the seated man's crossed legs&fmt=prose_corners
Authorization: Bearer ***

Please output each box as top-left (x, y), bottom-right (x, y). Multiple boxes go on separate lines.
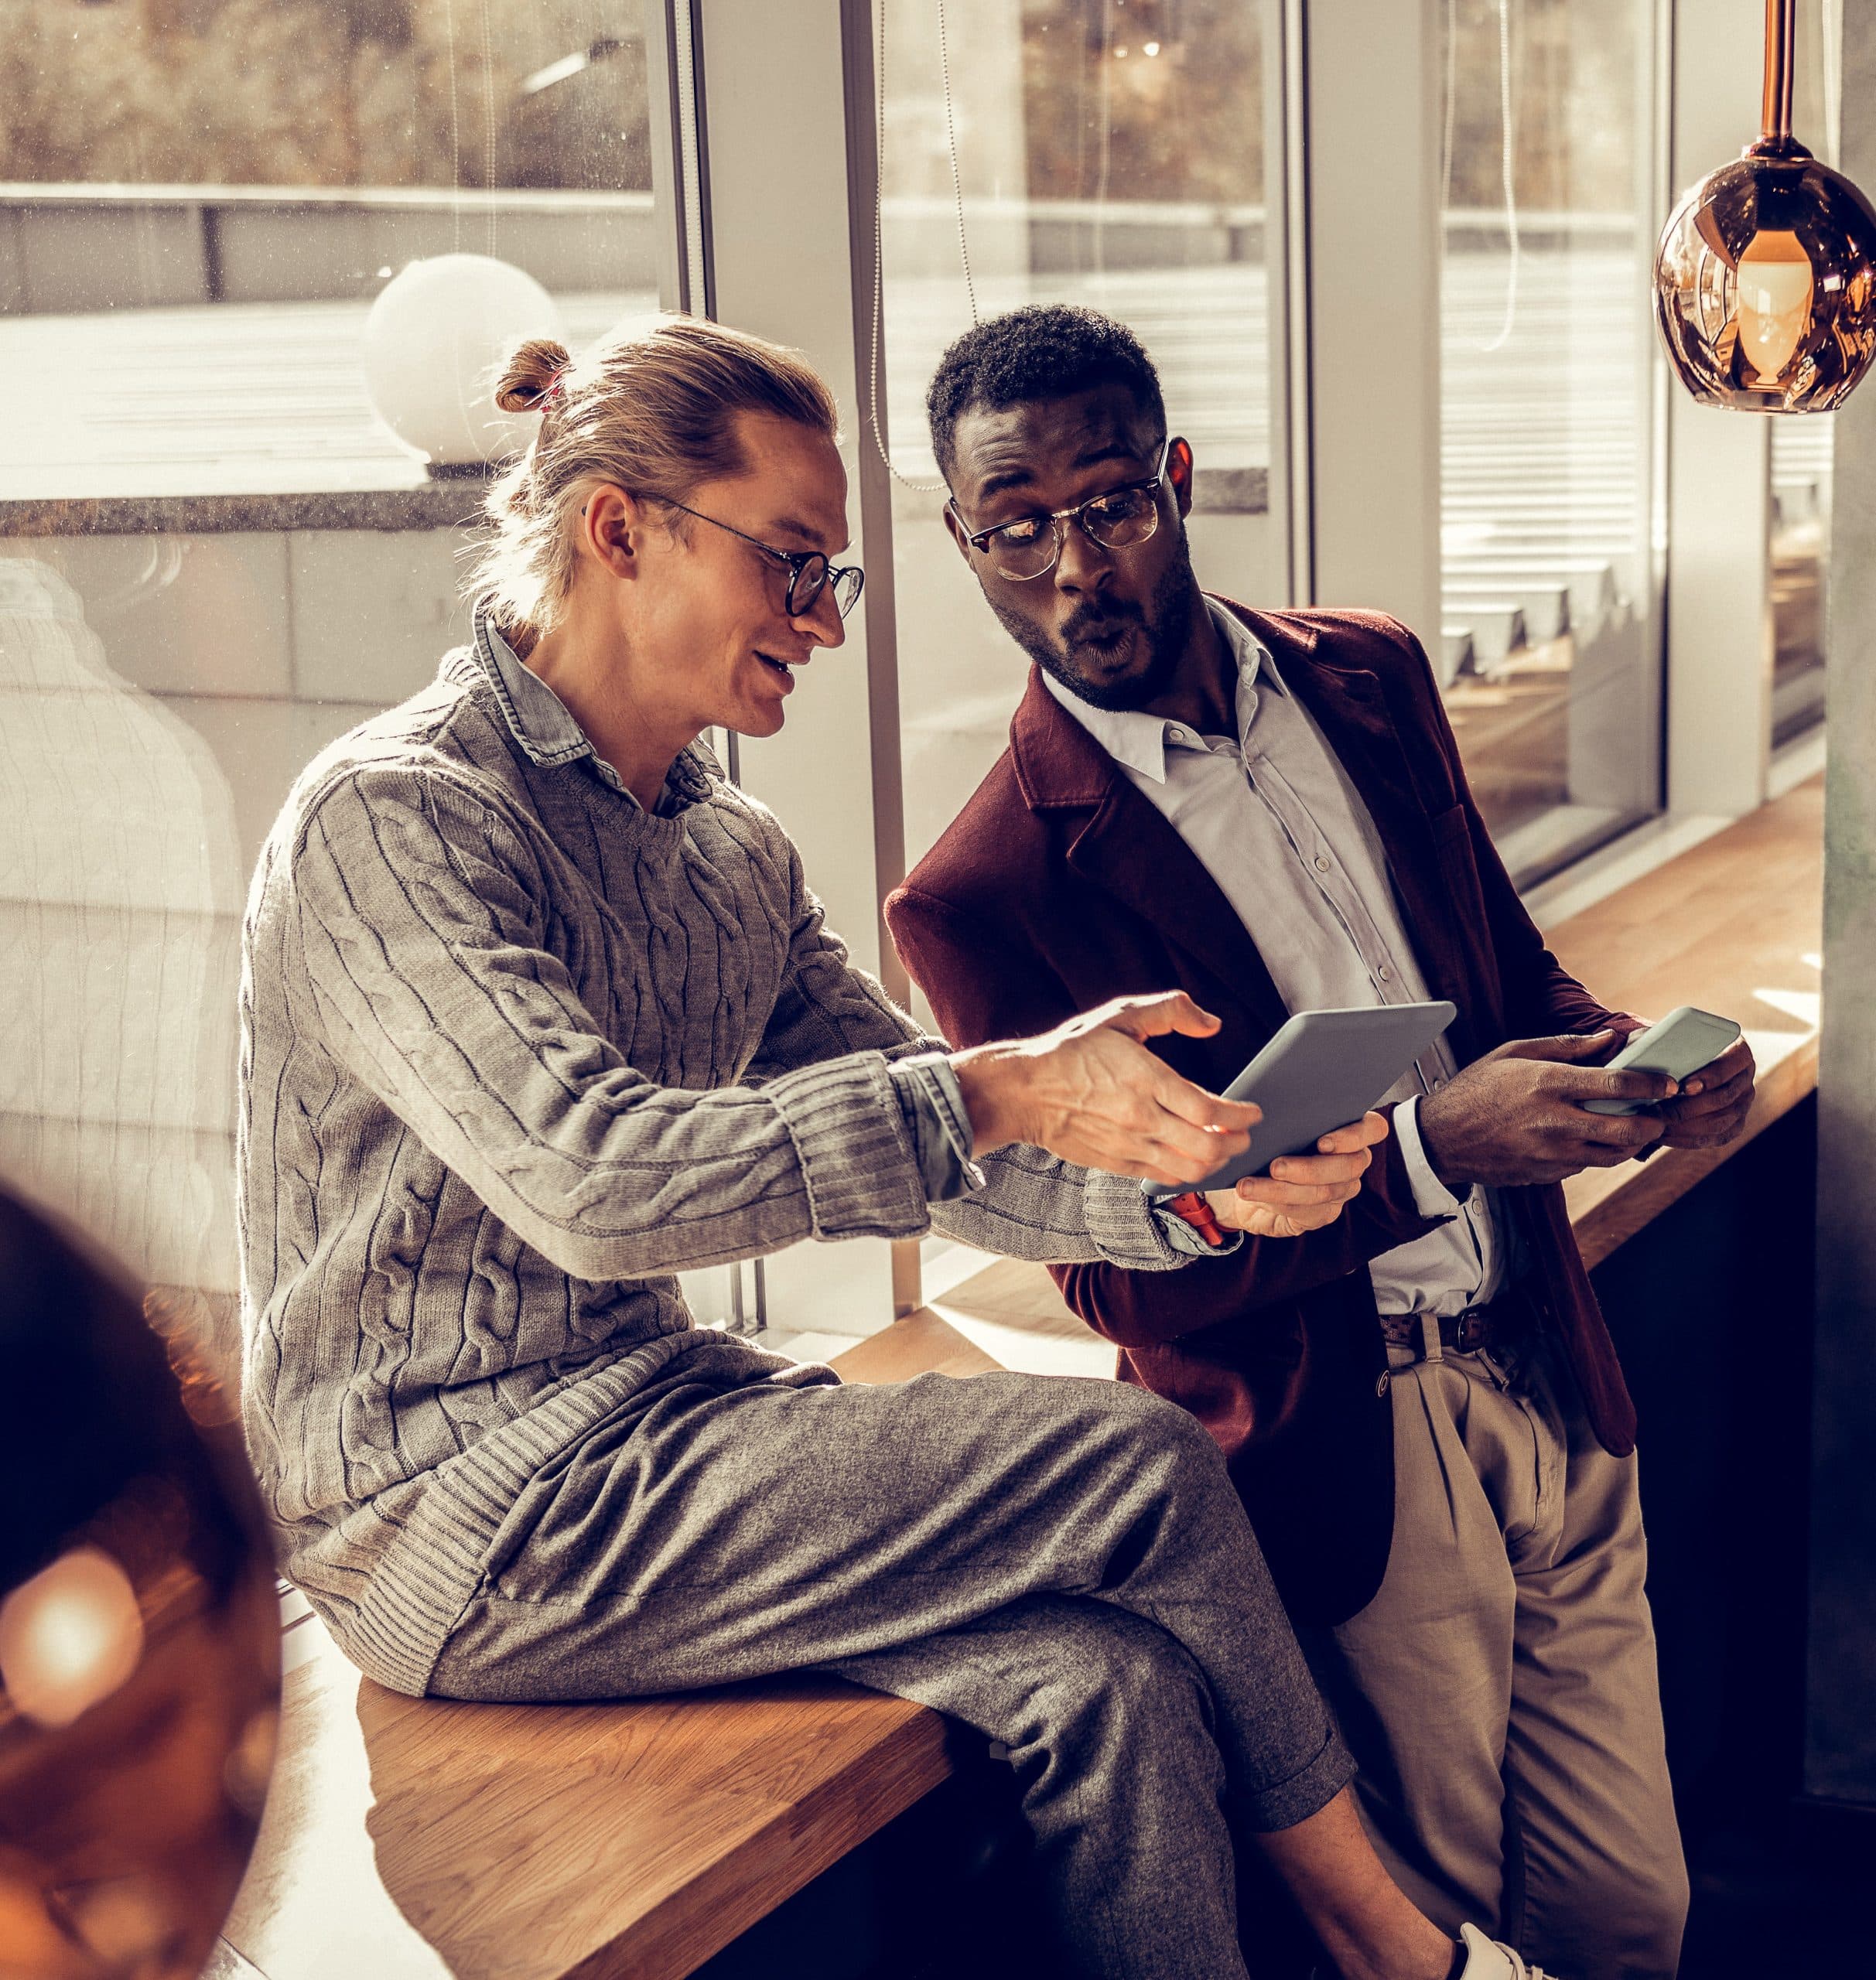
top-left (430, 1374), bottom-right (1353, 1980)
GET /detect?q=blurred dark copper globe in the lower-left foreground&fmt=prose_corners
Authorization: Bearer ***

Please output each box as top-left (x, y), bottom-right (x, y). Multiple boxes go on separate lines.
top-left (0, 1194), bottom-right (279, 1980)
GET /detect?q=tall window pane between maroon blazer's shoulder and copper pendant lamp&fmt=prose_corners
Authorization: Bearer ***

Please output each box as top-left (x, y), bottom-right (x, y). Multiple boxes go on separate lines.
top-left (1440, 0), bottom-right (1660, 883)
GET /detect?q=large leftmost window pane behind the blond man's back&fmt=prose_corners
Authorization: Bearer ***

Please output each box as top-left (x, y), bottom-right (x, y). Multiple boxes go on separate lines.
top-left (0, 0), bottom-right (729, 1348)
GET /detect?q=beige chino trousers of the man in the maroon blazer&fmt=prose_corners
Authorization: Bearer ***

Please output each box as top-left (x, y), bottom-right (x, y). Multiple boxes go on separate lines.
top-left (1304, 1334), bottom-right (1688, 1980)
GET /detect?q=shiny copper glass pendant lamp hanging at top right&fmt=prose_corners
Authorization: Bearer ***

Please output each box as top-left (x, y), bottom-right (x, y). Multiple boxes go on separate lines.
top-left (1654, 0), bottom-right (1876, 411)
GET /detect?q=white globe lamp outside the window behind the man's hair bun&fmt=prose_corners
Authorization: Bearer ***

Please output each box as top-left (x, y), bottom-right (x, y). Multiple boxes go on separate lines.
top-left (363, 254), bottom-right (561, 475)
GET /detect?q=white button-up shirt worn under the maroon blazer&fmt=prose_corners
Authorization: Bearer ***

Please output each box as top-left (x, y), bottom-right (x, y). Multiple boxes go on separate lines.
top-left (1044, 604), bottom-right (1505, 1315)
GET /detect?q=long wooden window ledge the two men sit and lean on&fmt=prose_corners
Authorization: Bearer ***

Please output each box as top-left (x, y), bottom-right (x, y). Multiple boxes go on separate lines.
top-left (224, 782), bottom-right (1823, 1980)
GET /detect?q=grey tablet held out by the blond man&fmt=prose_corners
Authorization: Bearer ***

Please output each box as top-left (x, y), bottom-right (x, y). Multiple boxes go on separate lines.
top-left (1141, 1002), bottom-right (1458, 1202)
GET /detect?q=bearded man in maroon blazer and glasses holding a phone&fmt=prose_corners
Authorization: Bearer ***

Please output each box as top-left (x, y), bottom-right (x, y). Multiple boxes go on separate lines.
top-left (887, 307), bottom-right (1753, 1980)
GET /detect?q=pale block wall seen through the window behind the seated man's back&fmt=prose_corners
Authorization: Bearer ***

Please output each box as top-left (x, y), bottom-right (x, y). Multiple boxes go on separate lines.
top-left (0, 531), bottom-right (466, 1348)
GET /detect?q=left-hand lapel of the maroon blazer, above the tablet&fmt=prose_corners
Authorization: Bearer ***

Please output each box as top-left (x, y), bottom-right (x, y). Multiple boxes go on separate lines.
top-left (1010, 667), bottom-right (1287, 1032)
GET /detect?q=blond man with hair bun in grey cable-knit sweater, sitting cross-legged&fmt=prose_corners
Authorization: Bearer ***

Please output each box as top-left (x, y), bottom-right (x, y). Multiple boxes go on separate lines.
top-left (240, 321), bottom-right (1529, 1980)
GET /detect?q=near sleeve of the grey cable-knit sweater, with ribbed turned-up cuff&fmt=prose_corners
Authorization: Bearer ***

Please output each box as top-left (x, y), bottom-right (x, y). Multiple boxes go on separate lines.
top-left (293, 768), bottom-right (947, 1279)
